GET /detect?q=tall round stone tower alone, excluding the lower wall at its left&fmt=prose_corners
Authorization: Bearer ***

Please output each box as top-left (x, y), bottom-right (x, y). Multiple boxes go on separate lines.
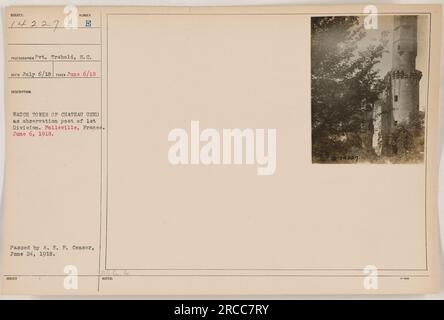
top-left (390, 16), bottom-right (422, 125)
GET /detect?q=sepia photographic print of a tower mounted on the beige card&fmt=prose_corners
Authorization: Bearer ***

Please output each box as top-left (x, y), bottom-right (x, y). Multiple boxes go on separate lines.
top-left (311, 15), bottom-right (429, 163)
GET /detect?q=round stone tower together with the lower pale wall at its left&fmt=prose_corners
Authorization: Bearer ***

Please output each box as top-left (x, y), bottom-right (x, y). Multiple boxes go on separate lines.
top-left (372, 16), bottom-right (422, 155)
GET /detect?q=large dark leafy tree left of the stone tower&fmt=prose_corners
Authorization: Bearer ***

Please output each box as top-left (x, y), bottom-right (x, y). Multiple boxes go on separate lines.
top-left (311, 16), bottom-right (387, 160)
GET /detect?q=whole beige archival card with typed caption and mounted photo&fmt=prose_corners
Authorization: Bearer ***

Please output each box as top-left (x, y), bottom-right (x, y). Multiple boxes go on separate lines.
top-left (1, 5), bottom-right (441, 295)
